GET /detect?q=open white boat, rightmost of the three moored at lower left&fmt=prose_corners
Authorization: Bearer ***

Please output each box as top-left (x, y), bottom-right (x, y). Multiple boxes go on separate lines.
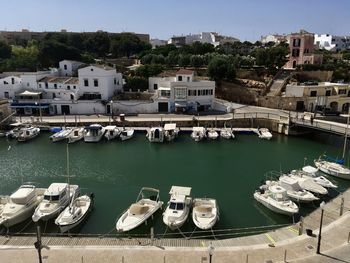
top-left (55, 194), bottom-right (94, 233)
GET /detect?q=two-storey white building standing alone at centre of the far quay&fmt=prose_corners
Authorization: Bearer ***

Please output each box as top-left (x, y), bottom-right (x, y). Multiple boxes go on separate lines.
top-left (149, 69), bottom-right (215, 112)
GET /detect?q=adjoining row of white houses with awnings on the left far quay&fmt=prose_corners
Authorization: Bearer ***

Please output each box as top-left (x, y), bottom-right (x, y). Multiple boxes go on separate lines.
top-left (0, 64), bottom-right (123, 115)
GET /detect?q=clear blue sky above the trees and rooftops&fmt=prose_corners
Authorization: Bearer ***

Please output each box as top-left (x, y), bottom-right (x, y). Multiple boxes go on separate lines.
top-left (0, 0), bottom-right (350, 41)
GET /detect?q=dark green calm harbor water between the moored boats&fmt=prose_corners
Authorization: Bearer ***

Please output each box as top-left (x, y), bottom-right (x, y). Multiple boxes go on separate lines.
top-left (0, 133), bottom-right (350, 238)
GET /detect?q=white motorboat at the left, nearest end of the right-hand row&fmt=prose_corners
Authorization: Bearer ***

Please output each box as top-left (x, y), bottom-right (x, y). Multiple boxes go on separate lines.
top-left (254, 185), bottom-right (299, 216)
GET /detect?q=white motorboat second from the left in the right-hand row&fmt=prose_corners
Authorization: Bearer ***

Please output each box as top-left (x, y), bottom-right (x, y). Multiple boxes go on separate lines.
top-left (278, 175), bottom-right (319, 203)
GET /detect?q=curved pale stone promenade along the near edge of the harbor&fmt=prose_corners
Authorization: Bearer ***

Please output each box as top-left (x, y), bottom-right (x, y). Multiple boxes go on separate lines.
top-left (0, 189), bottom-right (350, 263)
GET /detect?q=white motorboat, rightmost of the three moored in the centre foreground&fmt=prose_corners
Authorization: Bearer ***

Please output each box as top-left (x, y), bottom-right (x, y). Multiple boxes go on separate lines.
top-left (192, 198), bottom-right (219, 230)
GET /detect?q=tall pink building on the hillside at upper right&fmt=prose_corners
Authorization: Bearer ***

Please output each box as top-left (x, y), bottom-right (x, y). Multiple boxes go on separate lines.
top-left (284, 30), bottom-right (323, 68)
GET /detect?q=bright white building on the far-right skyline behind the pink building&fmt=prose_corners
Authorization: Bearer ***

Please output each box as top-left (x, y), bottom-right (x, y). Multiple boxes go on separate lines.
top-left (314, 34), bottom-right (350, 51)
